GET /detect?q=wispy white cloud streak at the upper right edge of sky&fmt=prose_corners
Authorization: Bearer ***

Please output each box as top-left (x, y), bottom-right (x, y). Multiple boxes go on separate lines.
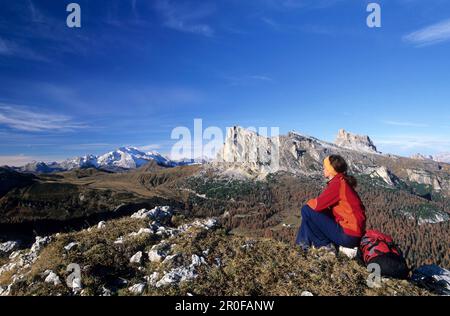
top-left (403, 19), bottom-right (450, 47)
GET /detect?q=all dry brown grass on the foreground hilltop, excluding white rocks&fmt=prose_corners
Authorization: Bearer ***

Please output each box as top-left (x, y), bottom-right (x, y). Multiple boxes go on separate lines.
top-left (3, 218), bottom-right (428, 296)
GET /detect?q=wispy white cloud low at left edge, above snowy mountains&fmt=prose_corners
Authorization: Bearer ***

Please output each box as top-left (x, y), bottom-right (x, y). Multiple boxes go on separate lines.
top-left (0, 103), bottom-right (87, 132)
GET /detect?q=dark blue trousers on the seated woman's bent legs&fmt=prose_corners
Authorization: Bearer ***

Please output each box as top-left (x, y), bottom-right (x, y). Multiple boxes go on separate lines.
top-left (296, 205), bottom-right (361, 248)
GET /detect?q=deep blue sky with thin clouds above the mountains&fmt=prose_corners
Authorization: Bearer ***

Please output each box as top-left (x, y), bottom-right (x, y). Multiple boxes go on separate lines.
top-left (0, 0), bottom-right (450, 165)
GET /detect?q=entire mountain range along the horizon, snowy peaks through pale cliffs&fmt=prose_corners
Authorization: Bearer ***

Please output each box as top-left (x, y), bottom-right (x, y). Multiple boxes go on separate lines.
top-left (6, 126), bottom-right (450, 179)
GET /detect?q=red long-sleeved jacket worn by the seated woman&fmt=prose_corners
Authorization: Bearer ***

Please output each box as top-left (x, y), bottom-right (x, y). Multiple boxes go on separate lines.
top-left (308, 173), bottom-right (366, 237)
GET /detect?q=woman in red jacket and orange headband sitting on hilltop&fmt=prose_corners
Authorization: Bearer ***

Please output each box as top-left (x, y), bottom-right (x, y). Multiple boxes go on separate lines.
top-left (296, 155), bottom-right (366, 250)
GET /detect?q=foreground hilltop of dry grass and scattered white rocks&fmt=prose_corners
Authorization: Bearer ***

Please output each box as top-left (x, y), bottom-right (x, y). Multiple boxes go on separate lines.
top-left (0, 212), bottom-right (436, 296)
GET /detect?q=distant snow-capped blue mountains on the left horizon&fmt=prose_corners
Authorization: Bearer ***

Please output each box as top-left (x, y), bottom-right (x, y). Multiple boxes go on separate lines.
top-left (14, 147), bottom-right (206, 173)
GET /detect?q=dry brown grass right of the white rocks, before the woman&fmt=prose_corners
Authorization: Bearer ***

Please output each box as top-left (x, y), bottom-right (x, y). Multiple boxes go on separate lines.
top-left (147, 232), bottom-right (428, 296)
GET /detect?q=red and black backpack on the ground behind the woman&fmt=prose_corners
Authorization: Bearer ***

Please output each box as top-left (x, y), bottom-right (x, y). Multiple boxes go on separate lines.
top-left (358, 230), bottom-right (409, 279)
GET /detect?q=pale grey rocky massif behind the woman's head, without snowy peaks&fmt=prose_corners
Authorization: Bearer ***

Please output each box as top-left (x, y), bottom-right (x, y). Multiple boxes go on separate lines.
top-left (211, 126), bottom-right (450, 195)
